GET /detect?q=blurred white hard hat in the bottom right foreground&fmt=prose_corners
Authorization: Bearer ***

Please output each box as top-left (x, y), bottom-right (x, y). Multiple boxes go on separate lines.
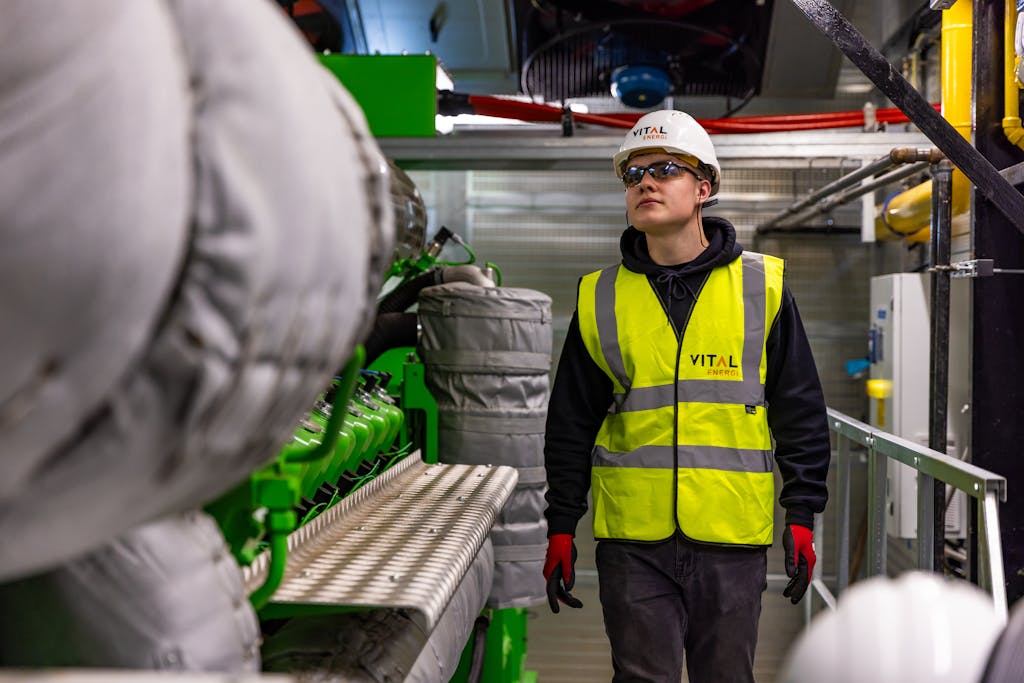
top-left (779, 571), bottom-right (1002, 683)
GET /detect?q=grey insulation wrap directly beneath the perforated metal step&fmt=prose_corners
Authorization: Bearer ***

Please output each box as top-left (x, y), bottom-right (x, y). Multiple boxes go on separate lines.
top-left (263, 539), bottom-right (495, 683)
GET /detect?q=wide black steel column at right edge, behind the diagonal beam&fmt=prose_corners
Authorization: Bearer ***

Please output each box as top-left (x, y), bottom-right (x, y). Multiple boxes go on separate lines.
top-left (961, 0), bottom-right (1024, 604)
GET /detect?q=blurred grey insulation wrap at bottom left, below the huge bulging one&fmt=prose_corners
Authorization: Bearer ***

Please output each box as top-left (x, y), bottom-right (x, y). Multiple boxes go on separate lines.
top-left (0, 512), bottom-right (260, 673)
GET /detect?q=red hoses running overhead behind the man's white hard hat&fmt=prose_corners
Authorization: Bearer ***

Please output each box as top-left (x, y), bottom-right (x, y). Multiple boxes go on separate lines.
top-left (460, 95), bottom-right (940, 133)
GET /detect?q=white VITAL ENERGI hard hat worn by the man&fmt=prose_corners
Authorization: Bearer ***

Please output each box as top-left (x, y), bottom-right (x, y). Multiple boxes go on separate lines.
top-left (611, 110), bottom-right (722, 197)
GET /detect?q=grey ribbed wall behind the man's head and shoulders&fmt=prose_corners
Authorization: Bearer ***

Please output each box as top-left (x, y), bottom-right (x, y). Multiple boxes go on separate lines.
top-left (410, 168), bottom-right (872, 417)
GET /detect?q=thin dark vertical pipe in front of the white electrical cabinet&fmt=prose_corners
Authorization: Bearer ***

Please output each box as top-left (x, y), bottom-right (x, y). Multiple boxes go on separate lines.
top-left (928, 160), bottom-right (953, 573)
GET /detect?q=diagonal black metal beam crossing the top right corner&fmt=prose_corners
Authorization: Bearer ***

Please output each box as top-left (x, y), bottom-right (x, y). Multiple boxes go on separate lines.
top-left (793, 0), bottom-right (1024, 232)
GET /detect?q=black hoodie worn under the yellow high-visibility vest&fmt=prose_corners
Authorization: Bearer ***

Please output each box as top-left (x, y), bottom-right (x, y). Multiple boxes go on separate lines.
top-left (544, 217), bottom-right (830, 536)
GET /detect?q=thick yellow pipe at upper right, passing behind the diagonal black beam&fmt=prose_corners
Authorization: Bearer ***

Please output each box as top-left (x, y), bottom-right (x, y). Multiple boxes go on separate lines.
top-left (874, 0), bottom-right (970, 242)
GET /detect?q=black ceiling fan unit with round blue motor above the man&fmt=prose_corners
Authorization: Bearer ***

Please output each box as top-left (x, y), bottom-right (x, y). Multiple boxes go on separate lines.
top-left (519, 0), bottom-right (772, 113)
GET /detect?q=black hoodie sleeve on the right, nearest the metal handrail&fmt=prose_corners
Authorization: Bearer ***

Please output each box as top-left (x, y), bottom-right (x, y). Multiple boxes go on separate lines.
top-left (765, 288), bottom-right (831, 528)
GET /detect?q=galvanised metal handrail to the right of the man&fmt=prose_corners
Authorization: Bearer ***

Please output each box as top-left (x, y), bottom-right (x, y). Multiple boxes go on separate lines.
top-left (804, 409), bottom-right (1007, 624)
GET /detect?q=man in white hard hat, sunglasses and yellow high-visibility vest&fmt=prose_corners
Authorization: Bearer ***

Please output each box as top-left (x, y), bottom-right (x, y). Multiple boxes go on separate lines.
top-left (544, 111), bottom-right (829, 683)
